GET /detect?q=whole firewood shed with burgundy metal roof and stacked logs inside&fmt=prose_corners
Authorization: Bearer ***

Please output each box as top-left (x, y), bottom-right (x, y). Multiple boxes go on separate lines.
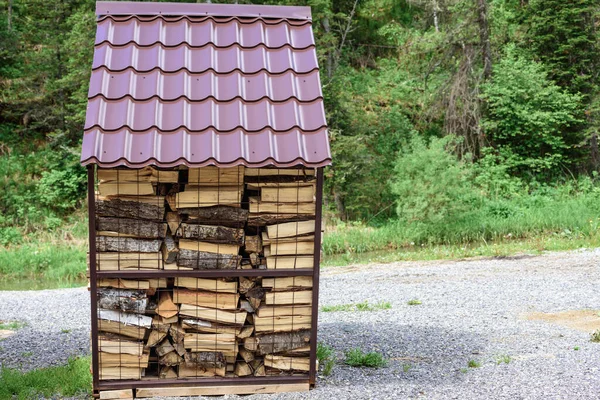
top-left (81, 2), bottom-right (331, 399)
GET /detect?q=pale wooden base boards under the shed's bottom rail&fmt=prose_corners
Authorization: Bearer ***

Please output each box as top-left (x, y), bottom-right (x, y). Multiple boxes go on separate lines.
top-left (100, 383), bottom-right (310, 400)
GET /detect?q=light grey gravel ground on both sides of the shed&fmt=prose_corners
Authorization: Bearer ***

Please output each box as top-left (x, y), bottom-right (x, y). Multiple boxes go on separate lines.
top-left (0, 250), bottom-right (600, 400)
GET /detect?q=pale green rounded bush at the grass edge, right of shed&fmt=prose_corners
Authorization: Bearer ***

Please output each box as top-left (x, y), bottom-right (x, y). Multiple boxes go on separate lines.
top-left (391, 137), bottom-right (481, 224)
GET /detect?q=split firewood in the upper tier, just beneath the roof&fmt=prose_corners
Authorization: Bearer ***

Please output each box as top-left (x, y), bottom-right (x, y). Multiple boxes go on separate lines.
top-left (96, 167), bottom-right (316, 271)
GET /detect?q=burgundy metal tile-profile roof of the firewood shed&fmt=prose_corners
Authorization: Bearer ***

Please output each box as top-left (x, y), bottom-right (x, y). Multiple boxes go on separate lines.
top-left (81, 2), bottom-right (331, 167)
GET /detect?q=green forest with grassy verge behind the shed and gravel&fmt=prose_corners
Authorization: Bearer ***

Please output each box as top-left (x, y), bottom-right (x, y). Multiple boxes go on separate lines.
top-left (0, 0), bottom-right (600, 287)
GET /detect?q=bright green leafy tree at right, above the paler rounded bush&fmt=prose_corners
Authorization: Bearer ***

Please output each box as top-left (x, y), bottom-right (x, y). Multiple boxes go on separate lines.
top-left (482, 47), bottom-right (583, 176)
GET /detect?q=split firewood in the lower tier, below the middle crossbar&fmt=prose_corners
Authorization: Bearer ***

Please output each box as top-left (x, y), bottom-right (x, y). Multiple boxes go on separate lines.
top-left (97, 276), bottom-right (312, 379)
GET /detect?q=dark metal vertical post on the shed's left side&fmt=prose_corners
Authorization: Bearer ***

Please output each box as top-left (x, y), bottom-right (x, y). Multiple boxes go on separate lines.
top-left (87, 164), bottom-right (99, 392)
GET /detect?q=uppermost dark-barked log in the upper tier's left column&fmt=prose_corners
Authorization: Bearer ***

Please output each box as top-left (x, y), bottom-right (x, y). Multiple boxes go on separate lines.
top-left (96, 196), bottom-right (165, 221)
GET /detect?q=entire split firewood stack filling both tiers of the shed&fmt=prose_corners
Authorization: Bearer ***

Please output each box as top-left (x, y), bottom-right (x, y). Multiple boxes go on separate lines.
top-left (96, 167), bottom-right (316, 380)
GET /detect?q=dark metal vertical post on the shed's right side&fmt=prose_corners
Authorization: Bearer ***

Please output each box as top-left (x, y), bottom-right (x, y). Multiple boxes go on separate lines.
top-left (309, 167), bottom-right (323, 386)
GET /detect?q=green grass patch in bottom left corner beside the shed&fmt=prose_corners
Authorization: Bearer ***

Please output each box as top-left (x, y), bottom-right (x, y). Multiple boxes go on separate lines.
top-left (0, 357), bottom-right (92, 400)
